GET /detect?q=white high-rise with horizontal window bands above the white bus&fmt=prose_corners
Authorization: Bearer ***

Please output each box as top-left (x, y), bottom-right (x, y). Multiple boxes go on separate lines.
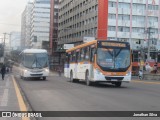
top-left (31, 0), bottom-right (50, 48)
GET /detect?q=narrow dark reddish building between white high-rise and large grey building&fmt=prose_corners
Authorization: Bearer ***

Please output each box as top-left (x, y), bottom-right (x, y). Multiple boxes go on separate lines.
top-left (49, 0), bottom-right (64, 70)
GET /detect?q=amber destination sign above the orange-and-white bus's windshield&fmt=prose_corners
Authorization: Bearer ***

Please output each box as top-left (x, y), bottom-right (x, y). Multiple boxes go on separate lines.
top-left (101, 42), bottom-right (126, 47)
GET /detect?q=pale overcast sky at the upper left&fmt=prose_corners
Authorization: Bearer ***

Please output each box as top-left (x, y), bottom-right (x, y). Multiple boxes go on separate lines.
top-left (0, 0), bottom-right (32, 41)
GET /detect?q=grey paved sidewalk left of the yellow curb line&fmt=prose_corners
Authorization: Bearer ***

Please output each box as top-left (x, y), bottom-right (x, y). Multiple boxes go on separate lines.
top-left (0, 74), bottom-right (20, 120)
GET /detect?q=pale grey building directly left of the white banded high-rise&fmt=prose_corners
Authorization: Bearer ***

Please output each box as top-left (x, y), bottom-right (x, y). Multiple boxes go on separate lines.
top-left (21, 2), bottom-right (33, 48)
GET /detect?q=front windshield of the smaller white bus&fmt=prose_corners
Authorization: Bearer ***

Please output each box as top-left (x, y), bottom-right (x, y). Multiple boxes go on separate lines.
top-left (22, 53), bottom-right (48, 68)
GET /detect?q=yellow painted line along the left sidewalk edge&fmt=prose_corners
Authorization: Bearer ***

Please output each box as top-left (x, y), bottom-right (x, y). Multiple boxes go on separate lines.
top-left (12, 75), bottom-right (30, 120)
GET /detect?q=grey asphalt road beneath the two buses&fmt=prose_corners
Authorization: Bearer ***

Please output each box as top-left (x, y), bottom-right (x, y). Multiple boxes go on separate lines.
top-left (13, 66), bottom-right (160, 120)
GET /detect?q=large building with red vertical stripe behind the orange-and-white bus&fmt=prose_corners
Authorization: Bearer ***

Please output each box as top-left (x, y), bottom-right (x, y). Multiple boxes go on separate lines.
top-left (58, 0), bottom-right (160, 49)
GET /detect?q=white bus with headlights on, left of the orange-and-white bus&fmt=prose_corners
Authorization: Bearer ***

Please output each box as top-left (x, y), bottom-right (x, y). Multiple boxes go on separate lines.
top-left (20, 49), bottom-right (49, 80)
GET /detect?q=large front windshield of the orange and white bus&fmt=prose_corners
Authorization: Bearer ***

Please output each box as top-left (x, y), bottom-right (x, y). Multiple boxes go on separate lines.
top-left (97, 47), bottom-right (131, 70)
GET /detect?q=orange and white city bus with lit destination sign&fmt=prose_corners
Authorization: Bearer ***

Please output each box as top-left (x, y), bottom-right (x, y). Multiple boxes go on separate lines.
top-left (64, 40), bottom-right (132, 87)
